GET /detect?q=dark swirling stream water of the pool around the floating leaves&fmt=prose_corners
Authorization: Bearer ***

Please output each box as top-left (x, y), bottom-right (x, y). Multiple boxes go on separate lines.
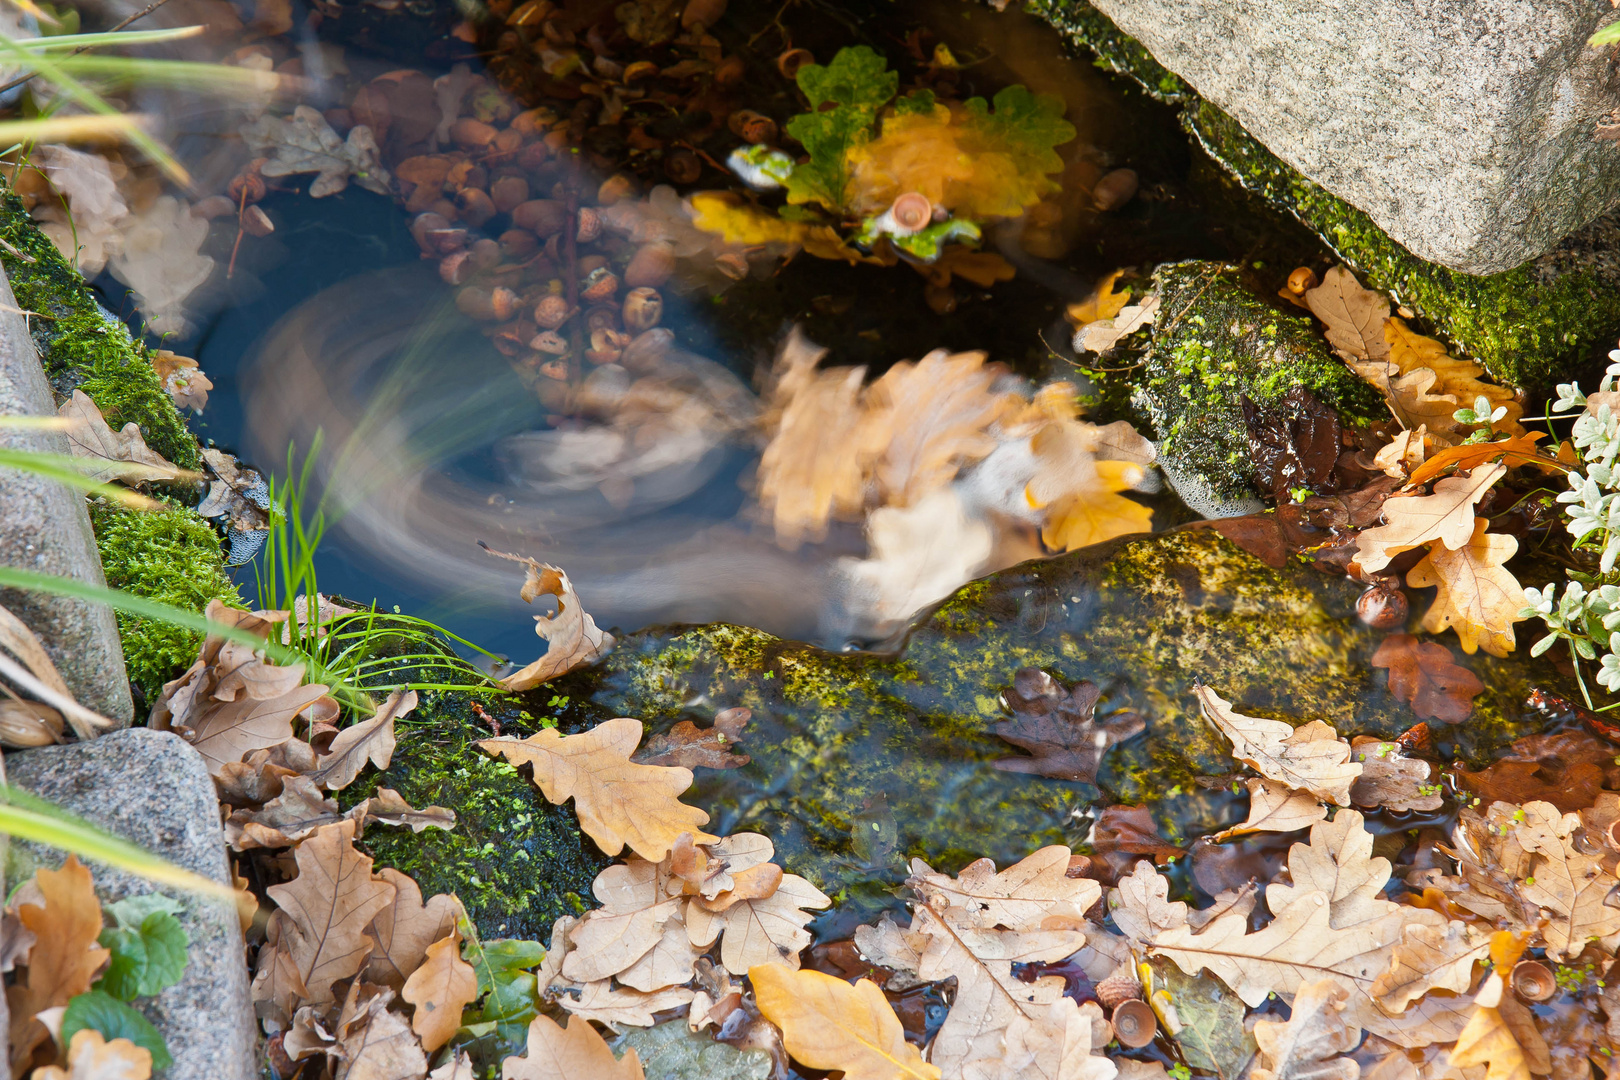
top-left (88, 0), bottom-right (1317, 659)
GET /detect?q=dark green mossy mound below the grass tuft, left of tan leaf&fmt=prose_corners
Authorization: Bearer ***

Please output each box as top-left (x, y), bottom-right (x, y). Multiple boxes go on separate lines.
top-left (342, 691), bottom-right (609, 941)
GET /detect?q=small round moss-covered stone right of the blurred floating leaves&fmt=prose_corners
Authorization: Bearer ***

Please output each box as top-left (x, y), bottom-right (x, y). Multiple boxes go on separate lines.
top-left (1098, 262), bottom-right (1388, 497)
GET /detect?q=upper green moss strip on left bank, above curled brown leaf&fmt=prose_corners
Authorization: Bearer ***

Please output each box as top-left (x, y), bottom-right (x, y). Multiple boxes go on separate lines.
top-left (0, 191), bottom-right (201, 470)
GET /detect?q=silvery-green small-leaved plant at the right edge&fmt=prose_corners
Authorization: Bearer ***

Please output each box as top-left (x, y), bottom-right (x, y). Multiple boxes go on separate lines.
top-left (1520, 348), bottom-right (1620, 704)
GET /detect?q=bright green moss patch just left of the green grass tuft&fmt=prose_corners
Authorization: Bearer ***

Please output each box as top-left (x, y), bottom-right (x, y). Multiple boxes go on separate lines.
top-left (89, 499), bottom-right (241, 701)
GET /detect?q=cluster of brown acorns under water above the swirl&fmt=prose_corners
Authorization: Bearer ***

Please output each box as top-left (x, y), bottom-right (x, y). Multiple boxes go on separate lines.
top-left (394, 97), bottom-right (693, 406)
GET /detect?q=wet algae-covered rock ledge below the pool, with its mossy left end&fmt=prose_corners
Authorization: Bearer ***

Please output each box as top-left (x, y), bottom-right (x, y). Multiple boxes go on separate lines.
top-left (367, 529), bottom-right (1544, 938)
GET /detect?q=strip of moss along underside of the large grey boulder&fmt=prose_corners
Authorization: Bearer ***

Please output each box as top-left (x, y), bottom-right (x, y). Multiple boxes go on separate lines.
top-left (1030, 0), bottom-right (1620, 393)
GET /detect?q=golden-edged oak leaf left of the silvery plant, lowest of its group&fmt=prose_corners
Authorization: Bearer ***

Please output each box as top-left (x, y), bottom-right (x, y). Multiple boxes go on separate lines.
top-left (1385, 518), bottom-right (1524, 656)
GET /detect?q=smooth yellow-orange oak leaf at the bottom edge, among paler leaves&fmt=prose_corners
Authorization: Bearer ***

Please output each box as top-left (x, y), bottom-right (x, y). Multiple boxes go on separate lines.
top-left (748, 963), bottom-right (941, 1080)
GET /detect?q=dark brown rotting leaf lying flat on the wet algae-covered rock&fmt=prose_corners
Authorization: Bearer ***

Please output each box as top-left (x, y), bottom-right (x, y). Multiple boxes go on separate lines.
top-left (995, 667), bottom-right (1147, 784)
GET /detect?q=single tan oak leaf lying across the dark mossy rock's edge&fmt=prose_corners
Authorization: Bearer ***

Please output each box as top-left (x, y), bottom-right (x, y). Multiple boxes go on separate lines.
top-left (478, 717), bottom-right (719, 863)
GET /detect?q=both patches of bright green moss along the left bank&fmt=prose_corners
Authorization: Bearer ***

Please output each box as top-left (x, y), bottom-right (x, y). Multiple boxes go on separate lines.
top-left (0, 189), bottom-right (241, 699)
